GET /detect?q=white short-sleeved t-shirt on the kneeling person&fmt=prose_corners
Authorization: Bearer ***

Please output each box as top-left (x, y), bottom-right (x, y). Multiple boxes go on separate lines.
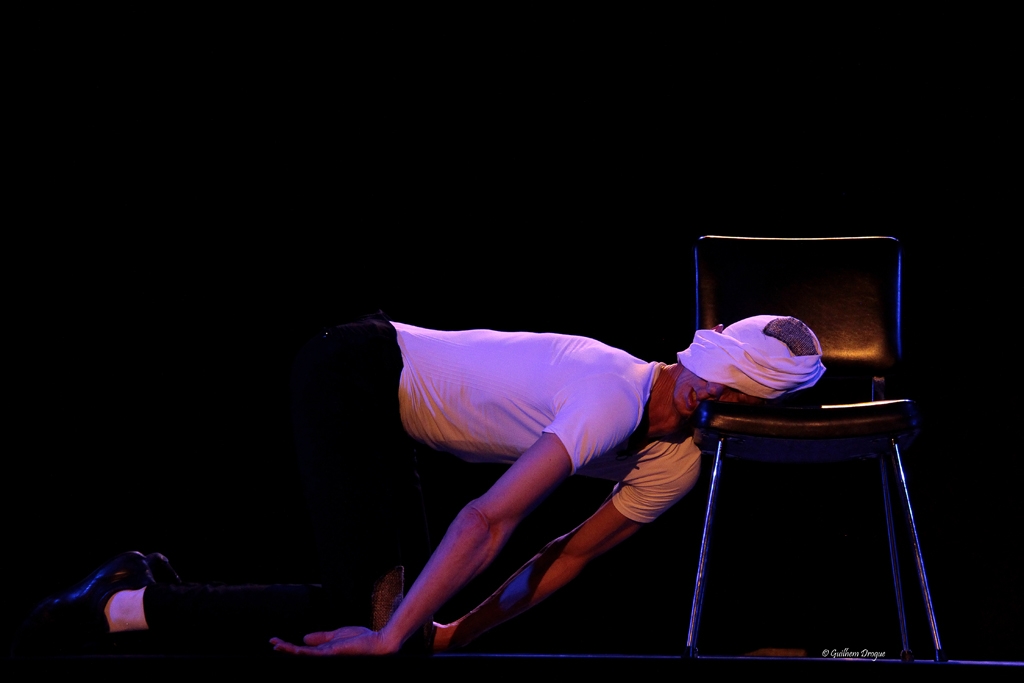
top-left (392, 323), bottom-right (700, 522)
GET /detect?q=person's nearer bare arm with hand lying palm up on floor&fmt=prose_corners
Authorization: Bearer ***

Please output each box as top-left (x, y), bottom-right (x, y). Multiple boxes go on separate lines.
top-left (270, 434), bottom-right (571, 654)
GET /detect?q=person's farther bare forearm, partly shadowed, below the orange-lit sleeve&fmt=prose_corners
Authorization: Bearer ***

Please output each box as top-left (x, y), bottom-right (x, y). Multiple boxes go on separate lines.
top-left (434, 493), bottom-right (643, 651)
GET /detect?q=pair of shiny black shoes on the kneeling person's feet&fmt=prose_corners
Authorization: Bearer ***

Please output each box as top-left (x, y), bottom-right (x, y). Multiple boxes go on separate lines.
top-left (11, 551), bottom-right (172, 656)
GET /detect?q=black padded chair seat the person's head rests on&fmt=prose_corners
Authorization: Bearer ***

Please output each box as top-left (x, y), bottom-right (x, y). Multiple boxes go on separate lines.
top-left (691, 399), bottom-right (921, 463)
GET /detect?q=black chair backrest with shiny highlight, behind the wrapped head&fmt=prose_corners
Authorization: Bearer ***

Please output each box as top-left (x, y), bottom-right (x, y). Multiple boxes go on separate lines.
top-left (694, 236), bottom-right (902, 400)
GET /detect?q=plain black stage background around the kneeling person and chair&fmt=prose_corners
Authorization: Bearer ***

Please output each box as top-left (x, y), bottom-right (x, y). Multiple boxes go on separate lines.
top-left (2, 10), bottom-right (1024, 660)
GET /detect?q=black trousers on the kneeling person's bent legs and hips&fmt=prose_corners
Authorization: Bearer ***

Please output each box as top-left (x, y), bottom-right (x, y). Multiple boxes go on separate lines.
top-left (145, 312), bottom-right (430, 642)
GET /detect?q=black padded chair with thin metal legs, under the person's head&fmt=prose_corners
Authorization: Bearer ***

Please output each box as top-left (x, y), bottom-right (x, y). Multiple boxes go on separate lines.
top-left (686, 236), bottom-right (946, 661)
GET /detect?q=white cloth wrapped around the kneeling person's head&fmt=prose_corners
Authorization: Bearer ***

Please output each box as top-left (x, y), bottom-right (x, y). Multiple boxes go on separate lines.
top-left (677, 315), bottom-right (825, 398)
